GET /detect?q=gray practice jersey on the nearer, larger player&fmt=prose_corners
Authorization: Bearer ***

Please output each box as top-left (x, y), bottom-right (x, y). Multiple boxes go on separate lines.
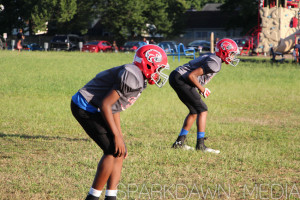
top-left (79, 64), bottom-right (147, 113)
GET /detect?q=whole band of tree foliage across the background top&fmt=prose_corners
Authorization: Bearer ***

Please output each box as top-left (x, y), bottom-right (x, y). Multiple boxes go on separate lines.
top-left (0, 0), bottom-right (232, 39)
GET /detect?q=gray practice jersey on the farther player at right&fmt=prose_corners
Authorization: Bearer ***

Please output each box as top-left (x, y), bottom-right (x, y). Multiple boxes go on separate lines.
top-left (176, 54), bottom-right (222, 86)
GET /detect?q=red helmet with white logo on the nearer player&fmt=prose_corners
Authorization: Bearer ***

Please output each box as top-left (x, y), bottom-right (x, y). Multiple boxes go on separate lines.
top-left (133, 44), bottom-right (169, 87)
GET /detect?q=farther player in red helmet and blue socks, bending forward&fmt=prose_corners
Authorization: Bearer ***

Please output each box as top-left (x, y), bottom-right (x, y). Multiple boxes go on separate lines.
top-left (169, 38), bottom-right (239, 154)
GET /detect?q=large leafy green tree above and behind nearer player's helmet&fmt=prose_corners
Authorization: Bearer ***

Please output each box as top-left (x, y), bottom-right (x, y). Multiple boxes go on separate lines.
top-left (94, 0), bottom-right (186, 40)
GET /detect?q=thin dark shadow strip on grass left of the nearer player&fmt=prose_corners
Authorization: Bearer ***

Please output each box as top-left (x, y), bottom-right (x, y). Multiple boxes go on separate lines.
top-left (0, 132), bottom-right (89, 141)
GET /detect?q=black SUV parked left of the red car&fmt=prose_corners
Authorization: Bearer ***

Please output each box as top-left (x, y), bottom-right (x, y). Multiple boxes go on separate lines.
top-left (50, 34), bottom-right (84, 51)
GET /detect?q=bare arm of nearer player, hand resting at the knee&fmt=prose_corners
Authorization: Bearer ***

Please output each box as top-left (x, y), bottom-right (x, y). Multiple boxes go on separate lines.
top-left (100, 90), bottom-right (126, 156)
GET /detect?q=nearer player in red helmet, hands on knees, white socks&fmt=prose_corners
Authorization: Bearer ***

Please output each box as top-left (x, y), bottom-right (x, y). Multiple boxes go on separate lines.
top-left (71, 45), bottom-right (169, 200)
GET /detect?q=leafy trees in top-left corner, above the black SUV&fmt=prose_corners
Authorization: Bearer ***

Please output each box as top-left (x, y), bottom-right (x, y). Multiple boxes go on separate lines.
top-left (0, 0), bottom-right (96, 34)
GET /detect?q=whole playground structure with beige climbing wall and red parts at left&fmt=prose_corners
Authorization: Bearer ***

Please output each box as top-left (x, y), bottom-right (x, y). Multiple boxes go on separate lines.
top-left (241, 0), bottom-right (300, 55)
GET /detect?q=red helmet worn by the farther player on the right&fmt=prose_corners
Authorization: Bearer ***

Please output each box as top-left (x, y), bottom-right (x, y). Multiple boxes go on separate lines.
top-left (216, 38), bottom-right (240, 66)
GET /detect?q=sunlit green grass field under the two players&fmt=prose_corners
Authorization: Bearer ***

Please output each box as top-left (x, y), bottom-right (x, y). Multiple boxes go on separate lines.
top-left (0, 51), bottom-right (300, 200)
